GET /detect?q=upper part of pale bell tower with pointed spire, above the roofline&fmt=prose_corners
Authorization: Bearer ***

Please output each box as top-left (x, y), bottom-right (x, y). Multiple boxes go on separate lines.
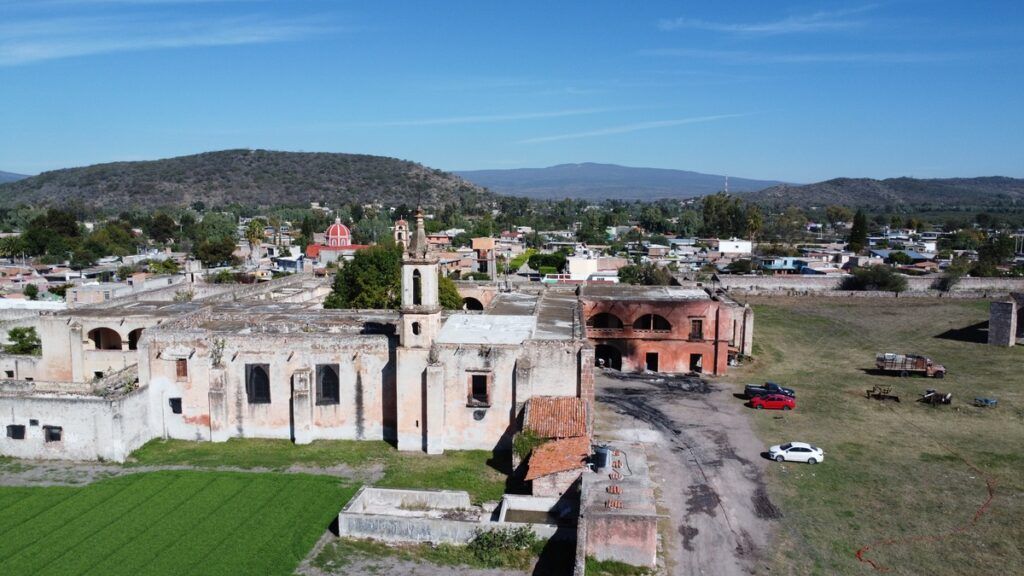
top-left (399, 209), bottom-right (441, 348)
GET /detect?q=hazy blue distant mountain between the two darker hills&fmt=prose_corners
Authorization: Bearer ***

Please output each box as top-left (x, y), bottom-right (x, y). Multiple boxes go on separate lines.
top-left (456, 163), bottom-right (779, 200)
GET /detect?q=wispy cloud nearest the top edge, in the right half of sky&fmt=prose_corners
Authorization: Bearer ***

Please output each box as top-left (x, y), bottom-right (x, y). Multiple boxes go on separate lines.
top-left (657, 5), bottom-right (874, 35)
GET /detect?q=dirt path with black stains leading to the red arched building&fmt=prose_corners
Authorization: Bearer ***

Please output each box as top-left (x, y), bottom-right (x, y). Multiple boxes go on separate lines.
top-left (595, 373), bottom-right (779, 576)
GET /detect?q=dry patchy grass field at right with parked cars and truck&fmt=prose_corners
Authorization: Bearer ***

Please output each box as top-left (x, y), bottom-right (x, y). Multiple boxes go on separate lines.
top-left (730, 298), bottom-right (1024, 575)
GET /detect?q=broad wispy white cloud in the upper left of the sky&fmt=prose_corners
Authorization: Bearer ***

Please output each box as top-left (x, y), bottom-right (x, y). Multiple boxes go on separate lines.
top-left (0, 15), bottom-right (329, 66)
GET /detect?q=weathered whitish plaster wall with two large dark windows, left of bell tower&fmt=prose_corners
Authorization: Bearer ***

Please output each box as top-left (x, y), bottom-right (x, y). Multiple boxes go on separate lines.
top-left (139, 332), bottom-right (394, 442)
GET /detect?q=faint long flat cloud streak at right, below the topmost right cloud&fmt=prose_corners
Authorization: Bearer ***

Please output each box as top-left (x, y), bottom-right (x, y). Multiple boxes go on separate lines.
top-left (638, 48), bottom-right (958, 64)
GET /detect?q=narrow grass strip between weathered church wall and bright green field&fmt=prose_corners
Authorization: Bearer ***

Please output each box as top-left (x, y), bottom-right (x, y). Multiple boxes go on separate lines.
top-left (131, 439), bottom-right (506, 503)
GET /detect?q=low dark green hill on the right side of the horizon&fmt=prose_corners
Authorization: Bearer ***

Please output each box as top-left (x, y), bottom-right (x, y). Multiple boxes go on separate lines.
top-left (744, 176), bottom-right (1024, 209)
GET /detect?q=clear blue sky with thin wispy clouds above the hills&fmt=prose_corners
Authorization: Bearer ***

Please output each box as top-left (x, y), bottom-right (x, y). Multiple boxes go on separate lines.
top-left (0, 0), bottom-right (1024, 181)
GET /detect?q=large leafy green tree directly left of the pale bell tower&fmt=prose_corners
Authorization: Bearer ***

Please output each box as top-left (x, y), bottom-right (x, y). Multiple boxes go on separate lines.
top-left (324, 246), bottom-right (401, 310)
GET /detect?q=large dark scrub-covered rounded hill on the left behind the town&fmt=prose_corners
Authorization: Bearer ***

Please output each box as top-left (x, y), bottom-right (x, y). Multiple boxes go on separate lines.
top-left (0, 150), bottom-right (494, 210)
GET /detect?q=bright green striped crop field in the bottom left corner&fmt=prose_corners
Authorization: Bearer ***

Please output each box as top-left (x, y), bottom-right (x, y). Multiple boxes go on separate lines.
top-left (0, 470), bottom-right (355, 576)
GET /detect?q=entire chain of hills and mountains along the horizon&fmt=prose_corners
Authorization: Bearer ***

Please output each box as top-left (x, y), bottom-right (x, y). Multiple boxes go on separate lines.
top-left (0, 150), bottom-right (1024, 211)
